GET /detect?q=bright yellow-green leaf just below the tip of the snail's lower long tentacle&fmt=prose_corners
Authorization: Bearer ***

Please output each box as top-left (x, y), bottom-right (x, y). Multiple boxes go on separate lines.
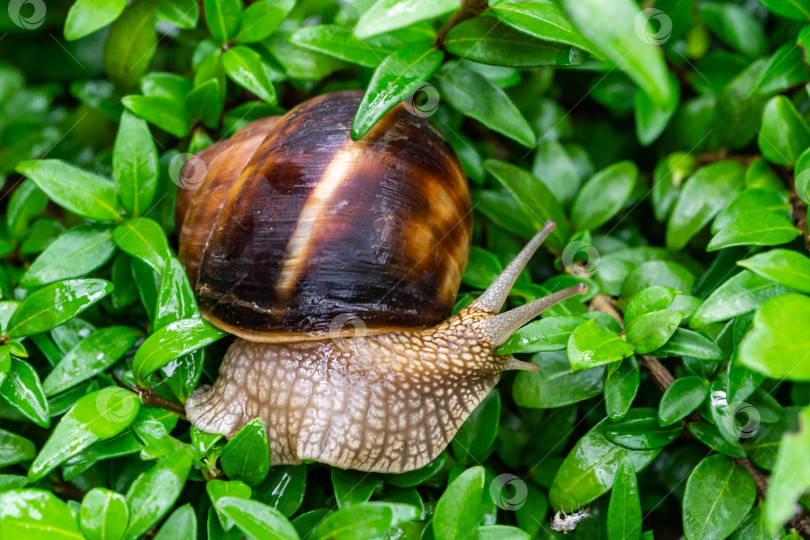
top-left (567, 320), bottom-right (633, 371)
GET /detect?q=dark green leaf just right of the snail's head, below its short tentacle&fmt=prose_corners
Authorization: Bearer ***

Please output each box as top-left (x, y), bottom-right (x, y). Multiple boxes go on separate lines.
top-left (512, 352), bottom-right (605, 409)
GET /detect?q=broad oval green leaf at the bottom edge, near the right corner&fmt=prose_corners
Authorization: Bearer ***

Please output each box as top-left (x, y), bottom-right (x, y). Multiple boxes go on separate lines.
top-left (683, 455), bottom-right (757, 540)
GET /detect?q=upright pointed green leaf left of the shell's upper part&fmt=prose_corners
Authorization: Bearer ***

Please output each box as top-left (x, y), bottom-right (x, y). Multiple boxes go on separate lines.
top-left (113, 111), bottom-right (158, 216)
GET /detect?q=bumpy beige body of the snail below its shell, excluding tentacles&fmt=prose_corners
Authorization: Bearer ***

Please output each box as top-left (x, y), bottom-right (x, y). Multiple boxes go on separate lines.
top-left (186, 310), bottom-right (498, 473)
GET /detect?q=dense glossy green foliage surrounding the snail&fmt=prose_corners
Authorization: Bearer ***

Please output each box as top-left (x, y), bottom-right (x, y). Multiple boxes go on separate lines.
top-left (0, 0), bottom-right (810, 540)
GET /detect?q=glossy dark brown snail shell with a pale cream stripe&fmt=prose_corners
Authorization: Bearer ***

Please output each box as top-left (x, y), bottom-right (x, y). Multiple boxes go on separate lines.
top-left (175, 91), bottom-right (472, 341)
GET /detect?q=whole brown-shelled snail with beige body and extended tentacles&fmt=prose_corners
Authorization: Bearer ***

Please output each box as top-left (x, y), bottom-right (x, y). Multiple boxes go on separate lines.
top-left (177, 91), bottom-right (585, 473)
